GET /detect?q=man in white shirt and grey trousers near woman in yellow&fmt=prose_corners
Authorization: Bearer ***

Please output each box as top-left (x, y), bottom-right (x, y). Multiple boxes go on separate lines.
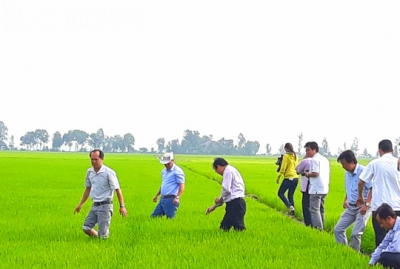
top-left (304, 142), bottom-right (330, 230)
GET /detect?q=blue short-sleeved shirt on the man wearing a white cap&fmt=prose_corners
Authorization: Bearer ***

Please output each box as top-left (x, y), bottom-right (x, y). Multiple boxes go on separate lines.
top-left (161, 164), bottom-right (185, 195)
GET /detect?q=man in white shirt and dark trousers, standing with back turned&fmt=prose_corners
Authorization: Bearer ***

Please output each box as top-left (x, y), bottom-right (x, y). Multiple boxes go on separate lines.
top-left (357, 139), bottom-right (400, 246)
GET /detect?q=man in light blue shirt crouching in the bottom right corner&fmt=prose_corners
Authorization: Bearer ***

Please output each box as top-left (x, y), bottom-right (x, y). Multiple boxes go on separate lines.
top-left (369, 203), bottom-right (400, 268)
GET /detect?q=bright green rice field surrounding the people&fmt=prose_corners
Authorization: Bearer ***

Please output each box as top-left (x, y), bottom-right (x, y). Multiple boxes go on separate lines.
top-left (0, 152), bottom-right (373, 268)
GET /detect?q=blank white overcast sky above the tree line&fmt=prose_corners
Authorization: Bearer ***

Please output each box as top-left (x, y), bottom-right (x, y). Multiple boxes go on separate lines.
top-left (0, 0), bottom-right (400, 153)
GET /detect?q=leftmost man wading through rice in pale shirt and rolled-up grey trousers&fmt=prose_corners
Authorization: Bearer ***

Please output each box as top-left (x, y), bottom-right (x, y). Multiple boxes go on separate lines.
top-left (74, 149), bottom-right (128, 239)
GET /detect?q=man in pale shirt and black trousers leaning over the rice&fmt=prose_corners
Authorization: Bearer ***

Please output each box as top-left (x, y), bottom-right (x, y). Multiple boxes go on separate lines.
top-left (206, 158), bottom-right (246, 231)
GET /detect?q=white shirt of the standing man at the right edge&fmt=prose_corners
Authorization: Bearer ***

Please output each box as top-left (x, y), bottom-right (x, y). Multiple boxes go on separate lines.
top-left (360, 153), bottom-right (400, 211)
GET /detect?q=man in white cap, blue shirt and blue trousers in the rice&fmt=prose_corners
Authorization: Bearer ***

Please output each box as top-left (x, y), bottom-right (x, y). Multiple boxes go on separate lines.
top-left (151, 152), bottom-right (185, 218)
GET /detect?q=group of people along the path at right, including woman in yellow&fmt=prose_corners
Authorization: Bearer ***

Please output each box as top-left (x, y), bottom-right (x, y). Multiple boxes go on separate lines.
top-left (277, 139), bottom-right (400, 268)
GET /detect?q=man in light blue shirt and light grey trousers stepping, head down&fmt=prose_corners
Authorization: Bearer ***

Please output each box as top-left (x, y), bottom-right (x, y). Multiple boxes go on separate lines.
top-left (334, 150), bottom-right (372, 251)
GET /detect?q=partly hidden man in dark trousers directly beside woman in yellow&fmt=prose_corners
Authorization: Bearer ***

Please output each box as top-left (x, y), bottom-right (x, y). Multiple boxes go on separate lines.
top-left (296, 155), bottom-right (311, 226)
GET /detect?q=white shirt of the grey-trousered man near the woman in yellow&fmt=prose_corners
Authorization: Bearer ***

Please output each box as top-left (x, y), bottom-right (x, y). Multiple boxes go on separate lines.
top-left (309, 152), bottom-right (331, 194)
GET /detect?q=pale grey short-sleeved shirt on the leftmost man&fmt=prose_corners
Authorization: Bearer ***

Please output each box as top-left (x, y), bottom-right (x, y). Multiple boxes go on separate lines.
top-left (85, 164), bottom-right (120, 202)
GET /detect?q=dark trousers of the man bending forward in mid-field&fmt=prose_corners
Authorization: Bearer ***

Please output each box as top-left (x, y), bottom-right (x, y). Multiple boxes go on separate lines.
top-left (219, 198), bottom-right (246, 231)
